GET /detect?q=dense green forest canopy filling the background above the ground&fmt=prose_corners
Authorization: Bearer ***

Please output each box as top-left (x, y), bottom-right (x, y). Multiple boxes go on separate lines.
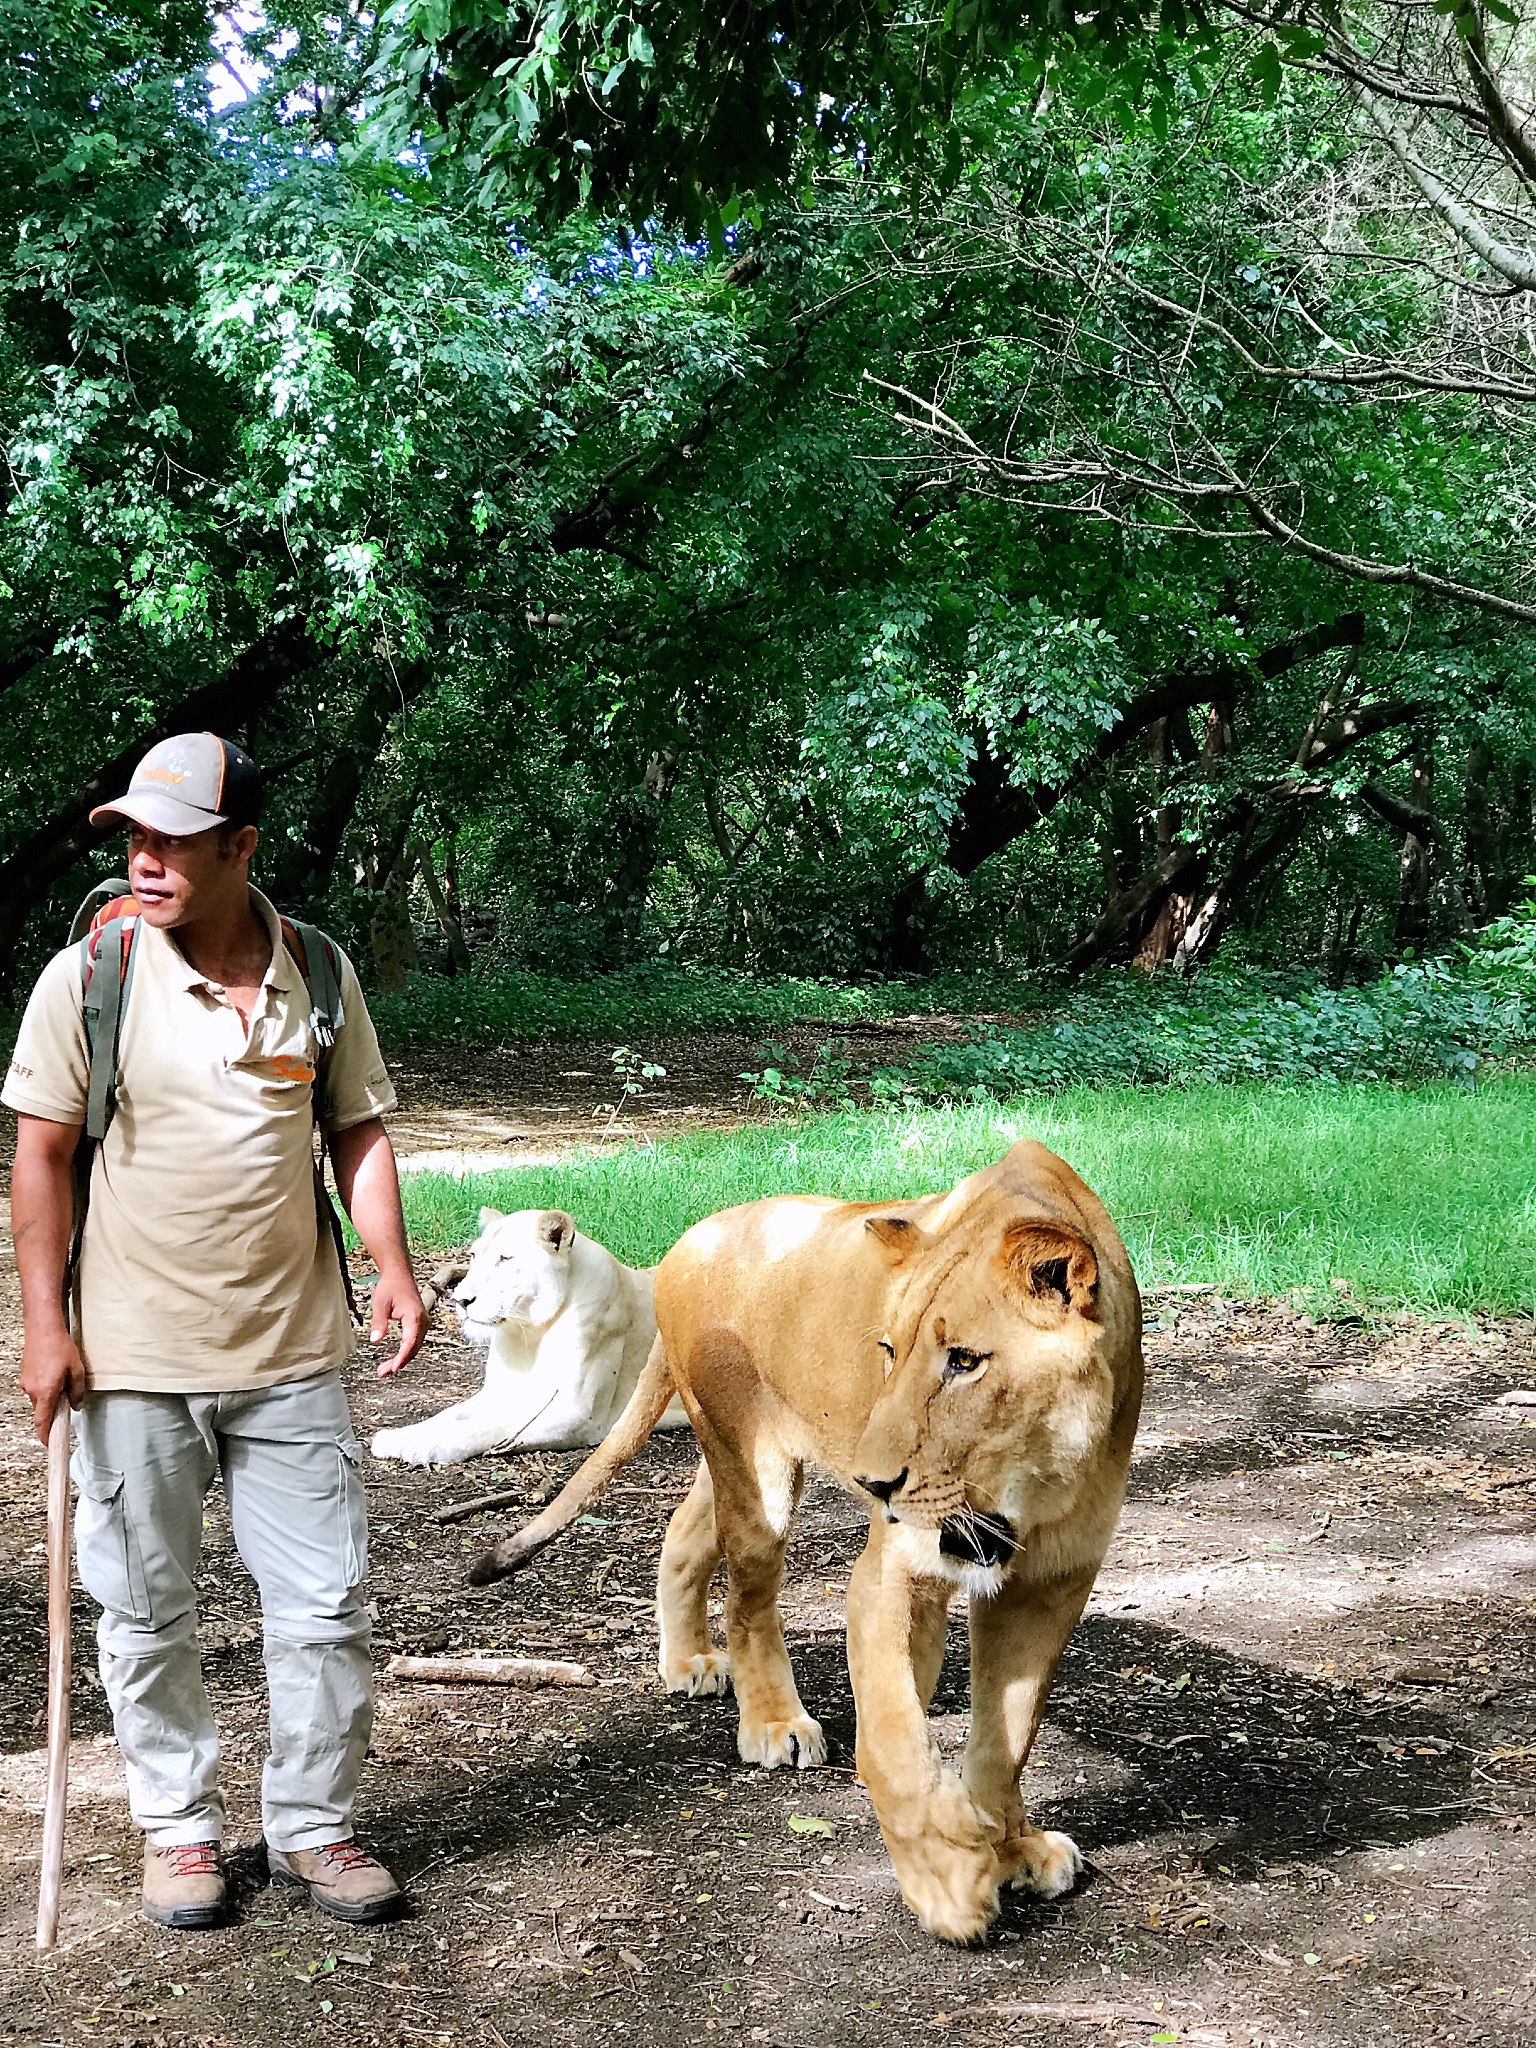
top-left (0, 0), bottom-right (1536, 987)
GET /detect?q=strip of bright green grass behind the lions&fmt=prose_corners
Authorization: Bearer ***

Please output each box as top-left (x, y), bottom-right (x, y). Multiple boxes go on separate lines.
top-left (393, 1075), bottom-right (1536, 1313)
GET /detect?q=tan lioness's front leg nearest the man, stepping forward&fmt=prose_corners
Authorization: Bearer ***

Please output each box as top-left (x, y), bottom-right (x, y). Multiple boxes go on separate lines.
top-left (848, 1522), bottom-right (1008, 1942)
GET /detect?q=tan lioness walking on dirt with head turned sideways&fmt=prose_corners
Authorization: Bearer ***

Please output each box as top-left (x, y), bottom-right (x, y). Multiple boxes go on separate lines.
top-left (471, 1143), bottom-right (1141, 1942)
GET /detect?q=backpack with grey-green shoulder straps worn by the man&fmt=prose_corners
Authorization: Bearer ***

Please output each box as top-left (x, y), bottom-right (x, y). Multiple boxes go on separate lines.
top-left (63, 881), bottom-right (356, 1319)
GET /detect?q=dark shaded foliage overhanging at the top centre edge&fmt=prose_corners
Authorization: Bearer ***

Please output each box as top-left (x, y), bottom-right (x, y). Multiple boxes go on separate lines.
top-left (373, 0), bottom-right (1200, 230)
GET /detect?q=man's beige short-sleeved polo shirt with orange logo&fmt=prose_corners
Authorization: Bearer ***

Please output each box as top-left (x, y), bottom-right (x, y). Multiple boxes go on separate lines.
top-left (0, 889), bottom-right (395, 1393)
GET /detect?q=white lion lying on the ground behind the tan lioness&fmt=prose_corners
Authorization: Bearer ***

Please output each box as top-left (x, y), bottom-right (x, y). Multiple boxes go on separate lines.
top-left (371, 1208), bottom-right (688, 1464)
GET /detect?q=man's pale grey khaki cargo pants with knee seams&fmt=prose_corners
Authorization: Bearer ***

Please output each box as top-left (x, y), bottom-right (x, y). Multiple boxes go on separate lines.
top-left (72, 1372), bottom-right (373, 1851)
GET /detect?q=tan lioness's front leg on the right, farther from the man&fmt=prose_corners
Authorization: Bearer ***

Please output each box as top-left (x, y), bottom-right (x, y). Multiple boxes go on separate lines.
top-left (965, 1565), bottom-right (1098, 1898)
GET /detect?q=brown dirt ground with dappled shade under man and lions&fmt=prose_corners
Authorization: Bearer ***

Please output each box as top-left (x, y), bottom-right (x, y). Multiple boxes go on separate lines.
top-left (0, 1049), bottom-right (1536, 2048)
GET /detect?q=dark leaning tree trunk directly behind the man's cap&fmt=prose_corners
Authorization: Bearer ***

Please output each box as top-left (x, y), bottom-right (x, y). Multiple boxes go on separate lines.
top-left (0, 621), bottom-right (315, 983)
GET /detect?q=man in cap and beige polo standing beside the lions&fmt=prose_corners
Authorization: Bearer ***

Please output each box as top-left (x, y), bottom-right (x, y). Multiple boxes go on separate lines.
top-left (0, 733), bottom-right (426, 1927)
